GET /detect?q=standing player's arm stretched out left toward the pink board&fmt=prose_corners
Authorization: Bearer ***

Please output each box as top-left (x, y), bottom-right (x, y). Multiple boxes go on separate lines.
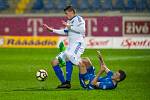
top-left (43, 24), bottom-right (68, 35)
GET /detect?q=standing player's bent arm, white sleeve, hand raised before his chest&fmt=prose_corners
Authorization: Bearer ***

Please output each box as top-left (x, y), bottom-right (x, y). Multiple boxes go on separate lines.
top-left (63, 19), bottom-right (85, 33)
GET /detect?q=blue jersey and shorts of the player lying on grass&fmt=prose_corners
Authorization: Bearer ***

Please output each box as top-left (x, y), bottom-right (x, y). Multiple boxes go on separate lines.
top-left (80, 71), bottom-right (117, 90)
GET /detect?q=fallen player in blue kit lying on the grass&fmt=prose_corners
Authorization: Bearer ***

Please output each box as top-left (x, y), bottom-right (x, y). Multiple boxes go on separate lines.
top-left (79, 51), bottom-right (126, 90)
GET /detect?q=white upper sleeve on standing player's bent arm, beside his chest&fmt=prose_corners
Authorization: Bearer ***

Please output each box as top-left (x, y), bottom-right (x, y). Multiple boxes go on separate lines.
top-left (70, 16), bottom-right (85, 33)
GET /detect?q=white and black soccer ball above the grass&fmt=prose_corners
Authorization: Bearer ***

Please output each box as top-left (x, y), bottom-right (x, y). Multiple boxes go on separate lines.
top-left (36, 69), bottom-right (48, 81)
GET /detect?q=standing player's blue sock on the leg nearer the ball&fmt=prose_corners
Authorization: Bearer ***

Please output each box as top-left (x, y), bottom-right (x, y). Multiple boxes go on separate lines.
top-left (53, 65), bottom-right (65, 83)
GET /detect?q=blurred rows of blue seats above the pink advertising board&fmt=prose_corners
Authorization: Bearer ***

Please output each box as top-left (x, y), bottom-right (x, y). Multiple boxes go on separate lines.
top-left (0, 0), bottom-right (150, 14)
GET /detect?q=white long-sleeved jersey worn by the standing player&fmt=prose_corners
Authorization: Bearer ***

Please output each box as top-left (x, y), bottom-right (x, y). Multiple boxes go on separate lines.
top-left (53, 15), bottom-right (85, 46)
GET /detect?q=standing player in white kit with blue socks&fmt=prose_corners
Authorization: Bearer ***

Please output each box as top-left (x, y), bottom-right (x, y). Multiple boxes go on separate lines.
top-left (43, 6), bottom-right (85, 88)
